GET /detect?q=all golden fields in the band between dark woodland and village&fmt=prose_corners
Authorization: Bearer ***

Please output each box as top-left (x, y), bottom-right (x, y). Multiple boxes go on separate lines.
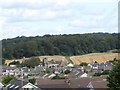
top-left (5, 53), bottom-right (118, 65)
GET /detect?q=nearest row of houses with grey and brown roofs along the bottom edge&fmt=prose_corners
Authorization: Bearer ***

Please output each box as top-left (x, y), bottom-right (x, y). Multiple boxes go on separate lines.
top-left (1, 76), bottom-right (108, 90)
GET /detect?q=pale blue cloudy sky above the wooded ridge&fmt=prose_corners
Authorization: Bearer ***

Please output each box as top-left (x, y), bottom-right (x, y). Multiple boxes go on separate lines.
top-left (0, 0), bottom-right (118, 39)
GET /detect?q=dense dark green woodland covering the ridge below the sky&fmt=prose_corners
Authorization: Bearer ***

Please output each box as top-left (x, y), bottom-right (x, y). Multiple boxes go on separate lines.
top-left (2, 33), bottom-right (119, 59)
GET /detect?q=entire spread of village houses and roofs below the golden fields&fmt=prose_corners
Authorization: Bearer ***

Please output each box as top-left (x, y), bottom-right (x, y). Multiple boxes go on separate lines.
top-left (0, 60), bottom-right (112, 90)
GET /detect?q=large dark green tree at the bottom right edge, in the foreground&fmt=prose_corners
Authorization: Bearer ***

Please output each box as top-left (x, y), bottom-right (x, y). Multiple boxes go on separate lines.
top-left (107, 60), bottom-right (120, 90)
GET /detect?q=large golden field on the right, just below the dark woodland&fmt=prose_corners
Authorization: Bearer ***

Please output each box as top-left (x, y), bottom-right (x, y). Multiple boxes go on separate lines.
top-left (70, 53), bottom-right (120, 65)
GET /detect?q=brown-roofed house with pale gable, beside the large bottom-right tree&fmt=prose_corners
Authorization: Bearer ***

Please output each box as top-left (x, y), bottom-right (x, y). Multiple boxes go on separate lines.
top-left (66, 75), bottom-right (108, 90)
